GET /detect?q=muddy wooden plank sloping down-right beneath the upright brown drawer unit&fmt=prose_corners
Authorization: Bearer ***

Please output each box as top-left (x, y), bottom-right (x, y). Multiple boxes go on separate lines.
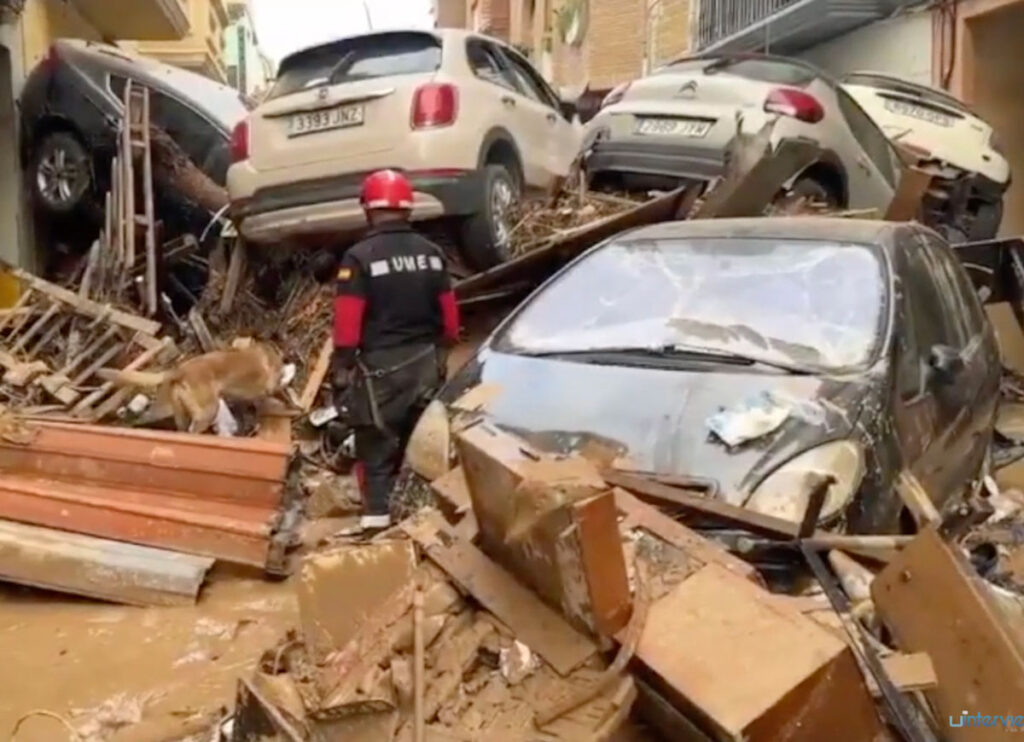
top-left (407, 513), bottom-right (597, 675)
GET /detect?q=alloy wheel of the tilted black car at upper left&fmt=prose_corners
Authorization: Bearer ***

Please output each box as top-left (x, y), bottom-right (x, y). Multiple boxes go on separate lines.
top-left (32, 132), bottom-right (92, 214)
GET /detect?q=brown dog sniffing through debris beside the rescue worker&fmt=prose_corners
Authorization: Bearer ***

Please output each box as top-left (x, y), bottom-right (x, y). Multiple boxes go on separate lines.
top-left (97, 343), bottom-right (285, 433)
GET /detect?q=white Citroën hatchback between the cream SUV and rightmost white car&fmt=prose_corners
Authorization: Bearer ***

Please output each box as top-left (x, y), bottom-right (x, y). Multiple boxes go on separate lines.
top-left (584, 54), bottom-right (901, 212)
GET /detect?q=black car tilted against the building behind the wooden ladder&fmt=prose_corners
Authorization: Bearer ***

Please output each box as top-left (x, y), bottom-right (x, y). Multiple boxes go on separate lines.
top-left (19, 39), bottom-right (247, 216)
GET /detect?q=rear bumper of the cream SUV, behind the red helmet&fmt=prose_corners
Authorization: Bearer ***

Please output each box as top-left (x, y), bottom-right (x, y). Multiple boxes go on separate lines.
top-left (229, 170), bottom-right (483, 243)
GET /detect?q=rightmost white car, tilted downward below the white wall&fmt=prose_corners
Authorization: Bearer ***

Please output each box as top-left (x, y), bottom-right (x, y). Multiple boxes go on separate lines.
top-left (843, 72), bottom-right (1011, 239)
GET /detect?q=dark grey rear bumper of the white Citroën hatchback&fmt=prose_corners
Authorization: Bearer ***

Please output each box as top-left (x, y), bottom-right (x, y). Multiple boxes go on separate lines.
top-left (586, 139), bottom-right (725, 180)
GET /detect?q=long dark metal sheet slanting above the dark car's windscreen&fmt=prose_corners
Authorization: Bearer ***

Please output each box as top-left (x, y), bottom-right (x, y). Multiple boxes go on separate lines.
top-left (455, 186), bottom-right (698, 302)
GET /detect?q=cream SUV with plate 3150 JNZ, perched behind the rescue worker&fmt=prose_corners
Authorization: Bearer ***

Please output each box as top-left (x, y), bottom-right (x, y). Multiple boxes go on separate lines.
top-left (227, 29), bottom-right (583, 268)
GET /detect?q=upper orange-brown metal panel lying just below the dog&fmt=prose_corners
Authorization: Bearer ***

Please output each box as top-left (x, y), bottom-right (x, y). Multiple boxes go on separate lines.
top-left (0, 423), bottom-right (290, 508)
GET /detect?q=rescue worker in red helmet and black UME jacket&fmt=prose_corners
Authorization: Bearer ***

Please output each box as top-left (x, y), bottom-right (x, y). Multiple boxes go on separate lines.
top-left (334, 170), bottom-right (459, 531)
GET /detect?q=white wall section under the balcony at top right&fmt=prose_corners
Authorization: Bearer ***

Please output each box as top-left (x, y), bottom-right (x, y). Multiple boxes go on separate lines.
top-left (798, 10), bottom-right (932, 85)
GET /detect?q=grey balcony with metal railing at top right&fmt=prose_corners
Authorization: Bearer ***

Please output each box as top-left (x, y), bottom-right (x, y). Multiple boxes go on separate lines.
top-left (697, 0), bottom-right (913, 54)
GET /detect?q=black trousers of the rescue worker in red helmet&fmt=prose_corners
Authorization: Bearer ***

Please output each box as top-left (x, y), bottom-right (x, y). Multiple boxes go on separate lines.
top-left (350, 345), bottom-right (443, 515)
